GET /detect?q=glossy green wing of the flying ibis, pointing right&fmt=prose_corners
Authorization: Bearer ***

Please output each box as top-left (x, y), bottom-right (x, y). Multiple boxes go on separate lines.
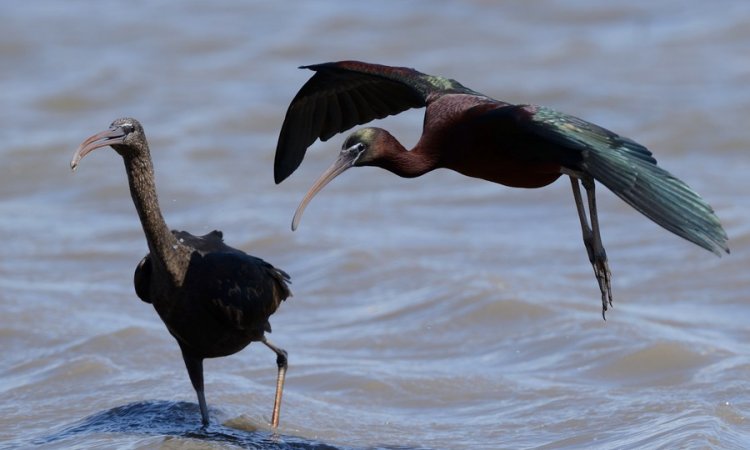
top-left (501, 105), bottom-right (729, 255)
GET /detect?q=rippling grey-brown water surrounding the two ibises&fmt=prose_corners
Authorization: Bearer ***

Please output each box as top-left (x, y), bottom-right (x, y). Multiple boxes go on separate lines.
top-left (0, 0), bottom-right (750, 449)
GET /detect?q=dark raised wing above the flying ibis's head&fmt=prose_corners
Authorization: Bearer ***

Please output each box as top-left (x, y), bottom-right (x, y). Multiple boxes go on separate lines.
top-left (274, 61), bottom-right (480, 183)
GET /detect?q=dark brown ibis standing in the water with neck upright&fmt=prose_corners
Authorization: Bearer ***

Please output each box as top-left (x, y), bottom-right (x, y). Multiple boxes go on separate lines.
top-left (70, 118), bottom-right (291, 427)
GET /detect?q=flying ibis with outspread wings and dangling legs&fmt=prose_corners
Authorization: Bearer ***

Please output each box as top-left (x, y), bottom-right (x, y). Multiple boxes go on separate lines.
top-left (274, 61), bottom-right (729, 315)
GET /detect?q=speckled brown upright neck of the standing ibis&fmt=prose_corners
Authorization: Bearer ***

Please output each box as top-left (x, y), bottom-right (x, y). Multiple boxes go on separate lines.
top-left (125, 155), bottom-right (185, 283)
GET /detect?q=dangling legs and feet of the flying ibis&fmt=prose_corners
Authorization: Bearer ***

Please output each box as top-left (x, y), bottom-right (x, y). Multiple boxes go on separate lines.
top-left (570, 175), bottom-right (612, 320)
